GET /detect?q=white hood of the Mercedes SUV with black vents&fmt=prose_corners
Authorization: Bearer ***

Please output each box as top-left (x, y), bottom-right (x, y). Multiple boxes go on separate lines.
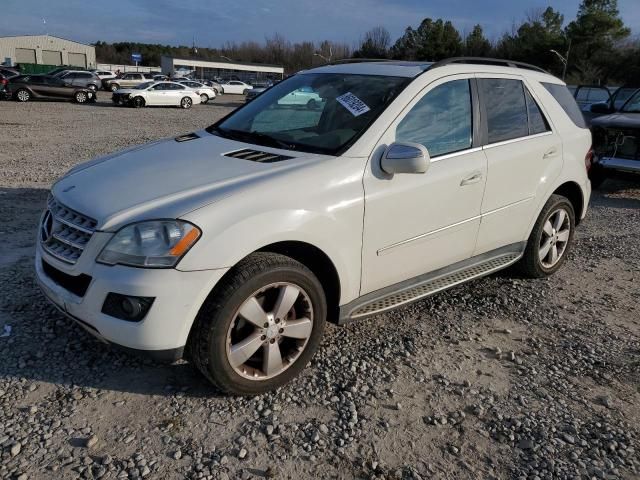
top-left (52, 131), bottom-right (324, 231)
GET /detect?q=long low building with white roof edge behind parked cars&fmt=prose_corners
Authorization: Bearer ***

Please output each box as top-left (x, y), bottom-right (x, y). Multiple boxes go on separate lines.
top-left (160, 55), bottom-right (284, 80)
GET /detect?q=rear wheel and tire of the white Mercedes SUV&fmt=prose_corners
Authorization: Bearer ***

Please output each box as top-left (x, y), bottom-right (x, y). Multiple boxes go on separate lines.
top-left (518, 195), bottom-right (576, 278)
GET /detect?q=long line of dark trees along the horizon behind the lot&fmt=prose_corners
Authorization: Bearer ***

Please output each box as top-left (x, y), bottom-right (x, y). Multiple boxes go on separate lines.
top-left (95, 0), bottom-right (640, 84)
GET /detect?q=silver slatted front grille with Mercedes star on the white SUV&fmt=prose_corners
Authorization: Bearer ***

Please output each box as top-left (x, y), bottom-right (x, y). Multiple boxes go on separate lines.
top-left (40, 197), bottom-right (97, 264)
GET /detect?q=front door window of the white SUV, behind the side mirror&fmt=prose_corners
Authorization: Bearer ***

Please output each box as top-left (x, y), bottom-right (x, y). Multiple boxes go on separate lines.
top-left (396, 80), bottom-right (472, 157)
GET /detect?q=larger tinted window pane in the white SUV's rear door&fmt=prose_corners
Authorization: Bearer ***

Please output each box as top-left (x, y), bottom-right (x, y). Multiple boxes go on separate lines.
top-left (479, 78), bottom-right (529, 143)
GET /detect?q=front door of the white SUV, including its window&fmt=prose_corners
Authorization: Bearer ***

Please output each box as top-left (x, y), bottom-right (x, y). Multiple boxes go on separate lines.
top-left (360, 76), bottom-right (486, 295)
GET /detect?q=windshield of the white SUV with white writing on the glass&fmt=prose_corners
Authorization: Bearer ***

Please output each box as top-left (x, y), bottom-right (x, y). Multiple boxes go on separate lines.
top-left (207, 73), bottom-right (412, 155)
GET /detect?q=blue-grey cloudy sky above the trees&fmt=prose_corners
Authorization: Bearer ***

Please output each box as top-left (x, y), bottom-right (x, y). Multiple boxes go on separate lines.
top-left (0, 0), bottom-right (640, 47)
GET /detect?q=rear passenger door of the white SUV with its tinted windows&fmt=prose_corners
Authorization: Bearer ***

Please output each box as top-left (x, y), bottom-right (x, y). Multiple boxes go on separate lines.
top-left (474, 74), bottom-right (562, 255)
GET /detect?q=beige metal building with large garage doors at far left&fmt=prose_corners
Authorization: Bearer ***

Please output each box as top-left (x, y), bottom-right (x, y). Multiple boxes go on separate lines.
top-left (0, 35), bottom-right (96, 68)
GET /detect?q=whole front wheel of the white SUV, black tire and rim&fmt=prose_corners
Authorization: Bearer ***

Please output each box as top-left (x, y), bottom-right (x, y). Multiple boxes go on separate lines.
top-left (188, 252), bottom-right (327, 395)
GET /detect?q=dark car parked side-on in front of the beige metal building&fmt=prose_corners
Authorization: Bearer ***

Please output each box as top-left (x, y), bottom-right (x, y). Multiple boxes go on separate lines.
top-left (7, 75), bottom-right (96, 103)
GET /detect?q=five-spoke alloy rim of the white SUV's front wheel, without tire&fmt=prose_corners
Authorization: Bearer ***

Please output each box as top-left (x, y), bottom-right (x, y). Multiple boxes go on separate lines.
top-left (226, 282), bottom-right (314, 380)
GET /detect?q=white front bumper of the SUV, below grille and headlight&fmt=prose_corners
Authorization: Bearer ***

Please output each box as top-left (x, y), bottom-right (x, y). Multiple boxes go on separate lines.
top-left (35, 242), bottom-right (227, 360)
